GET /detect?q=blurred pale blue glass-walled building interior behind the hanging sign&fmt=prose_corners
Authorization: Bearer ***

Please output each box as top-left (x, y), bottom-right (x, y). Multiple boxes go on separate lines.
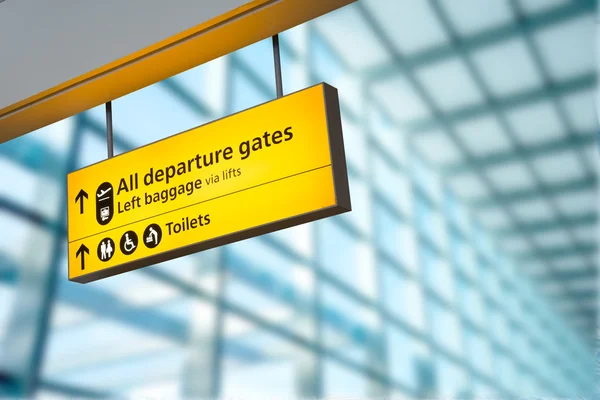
top-left (0, 0), bottom-right (598, 399)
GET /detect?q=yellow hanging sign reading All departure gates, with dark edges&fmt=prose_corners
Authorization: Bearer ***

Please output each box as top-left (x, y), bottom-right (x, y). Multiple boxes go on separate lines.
top-left (67, 84), bottom-right (351, 283)
